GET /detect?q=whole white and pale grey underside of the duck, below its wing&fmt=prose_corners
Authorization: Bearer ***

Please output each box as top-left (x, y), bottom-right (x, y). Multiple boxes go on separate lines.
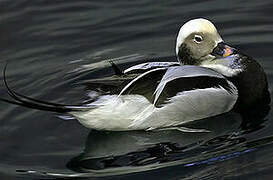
top-left (72, 81), bottom-right (238, 131)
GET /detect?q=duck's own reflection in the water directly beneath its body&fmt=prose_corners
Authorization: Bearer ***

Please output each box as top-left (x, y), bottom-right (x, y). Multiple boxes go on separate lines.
top-left (67, 112), bottom-right (241, 172)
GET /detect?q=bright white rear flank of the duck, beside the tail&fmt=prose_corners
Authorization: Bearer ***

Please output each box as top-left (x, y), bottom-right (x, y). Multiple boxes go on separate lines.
top-left (71, 95), bottom-right (154, 131)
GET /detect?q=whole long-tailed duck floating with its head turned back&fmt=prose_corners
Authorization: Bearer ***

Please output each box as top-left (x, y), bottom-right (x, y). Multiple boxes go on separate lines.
top-left (1, 18), bottom-right (270, 132)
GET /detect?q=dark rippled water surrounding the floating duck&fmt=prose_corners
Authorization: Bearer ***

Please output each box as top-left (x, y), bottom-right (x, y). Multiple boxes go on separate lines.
top-left (0, 0), bottom-right (273, 179)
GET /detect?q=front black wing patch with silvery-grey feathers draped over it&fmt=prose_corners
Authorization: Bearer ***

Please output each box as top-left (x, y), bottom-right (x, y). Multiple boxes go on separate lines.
top-left (153, 66), bottom-right (237, 107)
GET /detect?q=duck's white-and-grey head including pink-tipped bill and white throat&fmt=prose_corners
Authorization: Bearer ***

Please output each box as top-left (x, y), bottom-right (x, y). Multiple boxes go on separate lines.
top-left (176, 18), bottom-right (237, 76)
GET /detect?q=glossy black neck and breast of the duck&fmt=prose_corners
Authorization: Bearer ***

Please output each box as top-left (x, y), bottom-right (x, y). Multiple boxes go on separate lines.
top-left (227, 54), bottom-right (270, 112)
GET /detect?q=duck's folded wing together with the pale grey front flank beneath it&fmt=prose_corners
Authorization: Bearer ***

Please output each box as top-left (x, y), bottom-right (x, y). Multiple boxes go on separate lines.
top-left (120, 66), bottom-right (238, 129)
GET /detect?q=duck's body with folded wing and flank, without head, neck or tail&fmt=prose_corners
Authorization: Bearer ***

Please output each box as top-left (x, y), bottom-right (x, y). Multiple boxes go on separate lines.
top-left (72, 65), bottom-right (238, 131)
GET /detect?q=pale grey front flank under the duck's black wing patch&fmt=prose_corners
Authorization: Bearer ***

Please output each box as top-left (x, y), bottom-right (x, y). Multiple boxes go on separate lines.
top-left (130, 85), bottom-right (238, 130)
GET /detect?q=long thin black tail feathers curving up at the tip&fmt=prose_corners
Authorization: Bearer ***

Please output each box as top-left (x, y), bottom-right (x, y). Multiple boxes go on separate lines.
top-left (0, 64), bottom-right (91, 113)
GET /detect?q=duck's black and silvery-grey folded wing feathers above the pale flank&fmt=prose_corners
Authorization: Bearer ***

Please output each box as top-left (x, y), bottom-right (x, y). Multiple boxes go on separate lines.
top-left (119, 66), bottom-right (234, 107)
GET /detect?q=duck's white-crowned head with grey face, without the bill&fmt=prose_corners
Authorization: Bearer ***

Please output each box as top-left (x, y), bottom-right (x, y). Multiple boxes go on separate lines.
top-left (176, 18), bottom-right (223, 65)
